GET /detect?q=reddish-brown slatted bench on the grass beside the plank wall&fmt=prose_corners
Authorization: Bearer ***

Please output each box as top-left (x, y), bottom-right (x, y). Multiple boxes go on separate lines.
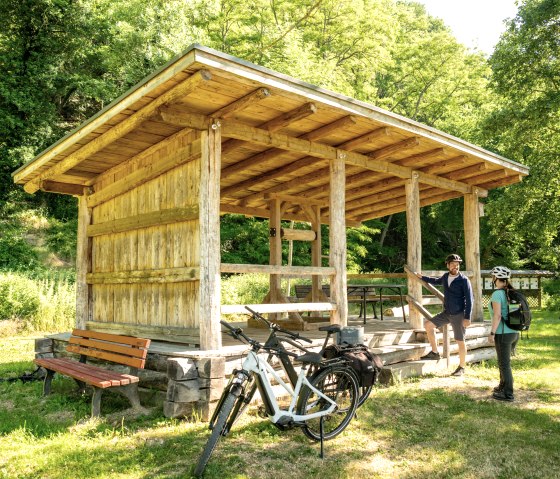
top-left (35, 329), bottom-right (150, 417)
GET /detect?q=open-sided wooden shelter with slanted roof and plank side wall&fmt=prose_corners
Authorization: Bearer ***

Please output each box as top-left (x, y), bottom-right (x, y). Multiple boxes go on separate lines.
top-left (14, 45), bottom-right (528, 350)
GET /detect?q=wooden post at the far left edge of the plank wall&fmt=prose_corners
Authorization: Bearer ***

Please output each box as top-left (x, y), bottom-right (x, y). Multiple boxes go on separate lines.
top-left (76, 194), bottom-right (93, 329)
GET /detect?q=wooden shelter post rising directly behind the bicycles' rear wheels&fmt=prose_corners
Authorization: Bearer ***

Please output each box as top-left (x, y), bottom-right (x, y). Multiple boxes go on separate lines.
top-left (329, 152), bottom-right (348, 326)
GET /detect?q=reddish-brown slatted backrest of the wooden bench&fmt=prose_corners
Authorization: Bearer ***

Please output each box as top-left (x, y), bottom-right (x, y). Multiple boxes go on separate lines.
top-left (66, 329), bottom-right (150, 369)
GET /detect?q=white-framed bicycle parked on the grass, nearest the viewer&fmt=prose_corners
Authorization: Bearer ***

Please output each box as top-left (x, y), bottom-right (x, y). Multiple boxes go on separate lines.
top-left (194, 312), bottom-right (358, 477)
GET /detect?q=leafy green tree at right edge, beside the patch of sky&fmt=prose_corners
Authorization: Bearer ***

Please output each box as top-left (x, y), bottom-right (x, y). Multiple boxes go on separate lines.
top-left (484, 0), bottom-right (560, 269)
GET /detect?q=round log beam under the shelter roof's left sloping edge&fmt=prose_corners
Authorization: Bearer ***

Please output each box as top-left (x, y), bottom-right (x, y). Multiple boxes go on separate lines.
top-left (24, 70), bottom-right (212, 193)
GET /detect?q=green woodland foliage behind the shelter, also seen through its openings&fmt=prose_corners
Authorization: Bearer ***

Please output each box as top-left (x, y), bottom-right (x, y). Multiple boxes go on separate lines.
top-left (0, 0), bottom-right (560, 271)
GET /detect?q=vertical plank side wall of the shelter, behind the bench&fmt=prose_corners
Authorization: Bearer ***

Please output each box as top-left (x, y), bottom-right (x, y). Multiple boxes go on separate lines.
top-left (88, 129), bottom-right (200, 340)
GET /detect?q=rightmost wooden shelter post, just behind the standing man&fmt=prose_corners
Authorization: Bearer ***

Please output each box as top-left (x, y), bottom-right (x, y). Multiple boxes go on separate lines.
top-left (464, 191), bottom-right (484, 322)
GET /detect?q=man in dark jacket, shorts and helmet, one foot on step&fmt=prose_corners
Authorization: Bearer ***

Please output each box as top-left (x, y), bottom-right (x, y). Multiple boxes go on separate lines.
top-left (416, 254), bottom-right (473, 376)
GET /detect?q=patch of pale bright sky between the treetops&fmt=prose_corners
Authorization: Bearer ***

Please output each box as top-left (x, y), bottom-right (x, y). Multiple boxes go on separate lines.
top-left (416, 0), bottom-right (517, 55)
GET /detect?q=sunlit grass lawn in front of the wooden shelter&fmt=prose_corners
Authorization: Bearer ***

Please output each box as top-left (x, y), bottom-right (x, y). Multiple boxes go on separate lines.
top-left (0, 313), bottom-right (560, 479)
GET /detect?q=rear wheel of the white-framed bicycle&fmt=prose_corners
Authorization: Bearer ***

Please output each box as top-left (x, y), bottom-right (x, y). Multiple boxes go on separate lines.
top-left (297, 366), bottom-right (359, 441)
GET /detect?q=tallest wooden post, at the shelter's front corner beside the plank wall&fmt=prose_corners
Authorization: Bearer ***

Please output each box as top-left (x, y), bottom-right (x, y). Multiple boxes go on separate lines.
top-left (198, 122), bottom-right (222, 350)
